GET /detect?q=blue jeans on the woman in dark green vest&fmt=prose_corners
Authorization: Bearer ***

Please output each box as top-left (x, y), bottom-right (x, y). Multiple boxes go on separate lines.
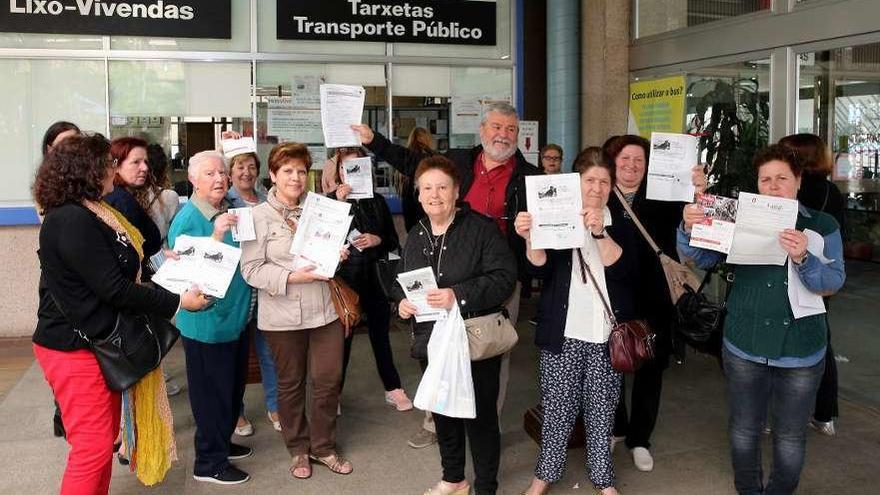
top-left (723, 349), bottom-right (825, 495)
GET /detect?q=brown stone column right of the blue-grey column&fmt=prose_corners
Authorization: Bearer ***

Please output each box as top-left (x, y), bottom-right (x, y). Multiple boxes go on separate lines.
top-left (581, 0), bottom-right (630, 148)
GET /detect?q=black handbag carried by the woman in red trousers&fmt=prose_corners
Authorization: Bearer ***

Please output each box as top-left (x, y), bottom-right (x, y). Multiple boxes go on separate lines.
top-left (52, 296), bottom-right (180, 392)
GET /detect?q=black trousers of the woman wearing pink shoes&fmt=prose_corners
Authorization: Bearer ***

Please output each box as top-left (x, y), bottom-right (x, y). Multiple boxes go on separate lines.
top-left (342, 284), bottom-right (401, 392)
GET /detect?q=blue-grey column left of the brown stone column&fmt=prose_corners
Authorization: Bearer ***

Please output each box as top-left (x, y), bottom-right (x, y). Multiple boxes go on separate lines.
top-left (548, 0), bottom-right (581, 170)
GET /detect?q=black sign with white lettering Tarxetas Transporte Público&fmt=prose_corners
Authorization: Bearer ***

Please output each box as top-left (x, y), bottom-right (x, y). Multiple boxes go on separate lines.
top-left (277, 0), bottom-right (496, 45)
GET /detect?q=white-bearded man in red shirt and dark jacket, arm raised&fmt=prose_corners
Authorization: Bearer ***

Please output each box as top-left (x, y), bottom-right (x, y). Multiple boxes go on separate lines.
top-left (352, 103), bottom-right (541, 448)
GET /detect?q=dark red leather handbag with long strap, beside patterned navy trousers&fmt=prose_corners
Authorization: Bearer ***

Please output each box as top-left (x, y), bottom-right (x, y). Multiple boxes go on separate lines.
top-left (577, 249), bottom-right (656, 373)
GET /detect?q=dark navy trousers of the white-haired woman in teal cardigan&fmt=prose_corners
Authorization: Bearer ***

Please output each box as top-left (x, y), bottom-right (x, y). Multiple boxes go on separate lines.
top-left (181, 332), bottom-right (248, 476)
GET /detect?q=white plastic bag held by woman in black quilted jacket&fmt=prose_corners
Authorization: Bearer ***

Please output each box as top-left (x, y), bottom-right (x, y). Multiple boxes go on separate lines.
top-left (413, 304), bottom-right (477, 419)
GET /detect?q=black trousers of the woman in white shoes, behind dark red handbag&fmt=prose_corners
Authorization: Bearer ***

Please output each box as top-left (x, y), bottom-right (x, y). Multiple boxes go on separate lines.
top-left (614, 356), bottom-right (668, 449)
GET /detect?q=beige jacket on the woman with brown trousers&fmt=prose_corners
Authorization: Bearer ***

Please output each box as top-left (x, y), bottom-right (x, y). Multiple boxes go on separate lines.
top-left (241, 189), bottom-right (339, 331)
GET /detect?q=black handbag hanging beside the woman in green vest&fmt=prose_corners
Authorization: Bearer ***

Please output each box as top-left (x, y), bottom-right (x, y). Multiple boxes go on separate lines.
top-left (675, 269), bottom-right (727, 344)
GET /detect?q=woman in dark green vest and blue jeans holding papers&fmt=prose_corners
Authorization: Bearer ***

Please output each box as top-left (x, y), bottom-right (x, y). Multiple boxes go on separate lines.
top-left (678, 145), bottom-right (845, 493)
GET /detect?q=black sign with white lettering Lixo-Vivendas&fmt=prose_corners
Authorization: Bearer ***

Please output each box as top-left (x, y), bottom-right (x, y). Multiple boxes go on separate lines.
top-left (0, 0), bottom-right (232, 39)
